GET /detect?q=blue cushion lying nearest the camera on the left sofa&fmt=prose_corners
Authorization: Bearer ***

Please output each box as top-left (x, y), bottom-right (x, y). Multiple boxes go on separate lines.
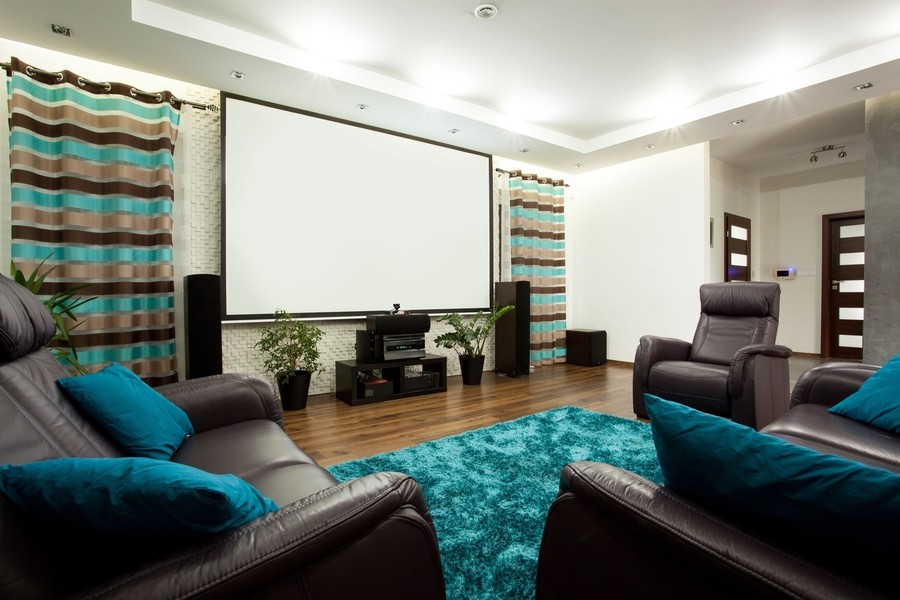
top-left (0, 457), bottom-right (278, 540)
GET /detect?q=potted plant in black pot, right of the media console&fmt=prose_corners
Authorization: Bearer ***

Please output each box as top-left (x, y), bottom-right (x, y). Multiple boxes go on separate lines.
top-left (434, 304), bottom-right (515, 385)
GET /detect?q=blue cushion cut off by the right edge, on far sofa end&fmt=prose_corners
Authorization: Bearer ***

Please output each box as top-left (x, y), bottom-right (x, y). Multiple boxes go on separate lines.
top-left (828, 354), bottom-right (900, 433)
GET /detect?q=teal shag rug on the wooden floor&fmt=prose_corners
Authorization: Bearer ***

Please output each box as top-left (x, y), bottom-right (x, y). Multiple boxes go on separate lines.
top-left (328, 406), bottom-right (662, 600)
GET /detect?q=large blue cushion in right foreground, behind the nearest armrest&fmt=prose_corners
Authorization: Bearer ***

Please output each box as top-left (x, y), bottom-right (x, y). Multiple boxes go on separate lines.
top-left (645, 394), bottom-right (900, 556)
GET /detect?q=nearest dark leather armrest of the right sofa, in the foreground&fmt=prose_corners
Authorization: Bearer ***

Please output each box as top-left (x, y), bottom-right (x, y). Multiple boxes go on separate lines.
top-left (537, 462), bottom-right (880, 600)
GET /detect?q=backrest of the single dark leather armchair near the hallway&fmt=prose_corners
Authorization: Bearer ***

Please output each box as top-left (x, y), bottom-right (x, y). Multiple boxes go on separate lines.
top-left (691, 282), bottom-right (781, 365)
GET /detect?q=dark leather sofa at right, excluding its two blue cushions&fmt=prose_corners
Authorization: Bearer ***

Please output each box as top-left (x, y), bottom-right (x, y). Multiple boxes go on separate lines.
top-left (537, 363), bottom-right (900, 600)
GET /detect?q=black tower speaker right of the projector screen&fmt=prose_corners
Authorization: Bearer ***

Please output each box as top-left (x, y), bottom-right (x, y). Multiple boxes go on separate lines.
top-left (494, 281), bottom-right (531, 377)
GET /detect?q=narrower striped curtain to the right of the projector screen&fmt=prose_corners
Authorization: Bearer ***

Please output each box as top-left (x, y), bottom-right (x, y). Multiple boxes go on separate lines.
top-left (509, 171), bottom-right (566, 366)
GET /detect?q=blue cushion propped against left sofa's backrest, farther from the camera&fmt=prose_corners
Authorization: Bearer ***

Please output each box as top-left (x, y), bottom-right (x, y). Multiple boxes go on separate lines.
top-left (56, 363), bottom-right (194, 460)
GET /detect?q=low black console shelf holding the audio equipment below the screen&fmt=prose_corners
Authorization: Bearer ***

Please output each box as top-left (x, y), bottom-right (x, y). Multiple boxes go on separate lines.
top-left (334, 354), bottom-right (447, 406)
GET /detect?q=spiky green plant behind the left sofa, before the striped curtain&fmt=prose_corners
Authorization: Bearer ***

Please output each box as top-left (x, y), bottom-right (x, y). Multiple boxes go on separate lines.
top-left (10, 254), bottom-right (97, 375)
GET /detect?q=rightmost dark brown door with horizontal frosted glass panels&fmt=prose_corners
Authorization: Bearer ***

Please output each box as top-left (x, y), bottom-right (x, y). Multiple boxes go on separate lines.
top-left (822, 211), bottom-right (866, 360)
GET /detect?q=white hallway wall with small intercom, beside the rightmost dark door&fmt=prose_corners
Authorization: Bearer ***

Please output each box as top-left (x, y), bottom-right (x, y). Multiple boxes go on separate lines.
top-left (759, 172), bottom-right (865, 354)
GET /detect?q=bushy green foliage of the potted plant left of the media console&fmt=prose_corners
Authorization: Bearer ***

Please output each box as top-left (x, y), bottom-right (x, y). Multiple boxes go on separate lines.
top-left (255, 309), bottom-right (323, 383)
